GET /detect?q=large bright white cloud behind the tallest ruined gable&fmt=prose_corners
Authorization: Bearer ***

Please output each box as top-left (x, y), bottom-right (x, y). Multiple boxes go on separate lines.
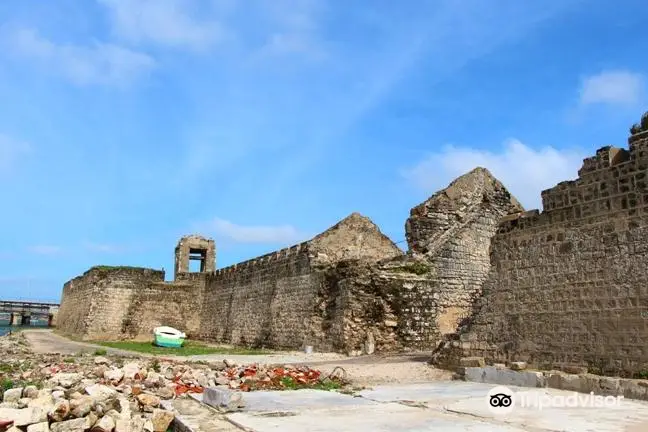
top-left (402, 139), bottom-right (587, 209)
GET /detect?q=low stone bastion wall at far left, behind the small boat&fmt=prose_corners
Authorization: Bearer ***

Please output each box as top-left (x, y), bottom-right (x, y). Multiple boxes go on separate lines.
top-left (58, 267), bottom-right (204, 340)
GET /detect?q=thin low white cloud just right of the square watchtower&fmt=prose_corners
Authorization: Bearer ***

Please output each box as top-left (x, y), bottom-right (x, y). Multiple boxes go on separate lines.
top-left (205, 218), bottom-right (305, 244)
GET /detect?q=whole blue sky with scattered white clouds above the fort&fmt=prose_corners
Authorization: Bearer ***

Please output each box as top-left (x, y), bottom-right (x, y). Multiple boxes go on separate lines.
top-left (0, 0), bottom-right (648, 300)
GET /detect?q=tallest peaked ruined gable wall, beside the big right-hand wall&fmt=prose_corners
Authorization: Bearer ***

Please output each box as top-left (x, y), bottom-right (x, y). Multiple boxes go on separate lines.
top-left (405, 168), bottom-right (523, 334)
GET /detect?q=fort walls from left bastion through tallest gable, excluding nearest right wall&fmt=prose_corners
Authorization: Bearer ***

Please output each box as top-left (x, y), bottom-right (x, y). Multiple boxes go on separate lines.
top-left (54, 168), bottom-right (521, 353)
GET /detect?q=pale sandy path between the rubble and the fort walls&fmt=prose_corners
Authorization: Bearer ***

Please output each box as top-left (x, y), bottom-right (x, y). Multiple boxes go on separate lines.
top-left (24, 330), bottom-right (451, 386)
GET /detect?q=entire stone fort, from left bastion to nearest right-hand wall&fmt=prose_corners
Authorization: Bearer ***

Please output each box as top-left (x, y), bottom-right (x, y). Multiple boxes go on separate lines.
top-left (59, 114), bottom-right (648, 374)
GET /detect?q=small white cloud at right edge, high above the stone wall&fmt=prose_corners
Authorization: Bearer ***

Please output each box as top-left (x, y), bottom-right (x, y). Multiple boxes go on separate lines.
top-left (580, 70), bottom-right (645, 105)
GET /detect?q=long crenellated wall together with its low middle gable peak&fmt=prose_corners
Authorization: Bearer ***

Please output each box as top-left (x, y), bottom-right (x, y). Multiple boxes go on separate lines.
top-left (197, 213), bottom-right (403, 350)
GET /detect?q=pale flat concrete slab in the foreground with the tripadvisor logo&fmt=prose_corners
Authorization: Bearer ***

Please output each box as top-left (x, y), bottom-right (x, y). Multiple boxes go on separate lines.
top-left (214, 381), bottom-right (648, 432)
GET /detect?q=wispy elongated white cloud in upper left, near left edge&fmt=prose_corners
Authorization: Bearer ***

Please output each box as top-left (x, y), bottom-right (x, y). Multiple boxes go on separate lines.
top-left (9, 29), bottom-right (155, 85)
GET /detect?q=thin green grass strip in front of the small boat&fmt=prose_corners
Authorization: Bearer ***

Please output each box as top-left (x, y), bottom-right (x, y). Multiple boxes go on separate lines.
top-left (92, 341), bottom-right (271, 356)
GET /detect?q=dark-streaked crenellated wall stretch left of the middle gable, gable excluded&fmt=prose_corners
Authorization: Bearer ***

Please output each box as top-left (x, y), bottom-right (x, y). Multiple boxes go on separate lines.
top-left (201, 243), bottom-right (319, 348)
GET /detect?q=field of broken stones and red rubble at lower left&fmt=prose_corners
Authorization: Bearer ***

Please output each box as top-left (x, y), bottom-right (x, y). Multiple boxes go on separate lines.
top-left (0, 333), bottom-right (345, 432)
